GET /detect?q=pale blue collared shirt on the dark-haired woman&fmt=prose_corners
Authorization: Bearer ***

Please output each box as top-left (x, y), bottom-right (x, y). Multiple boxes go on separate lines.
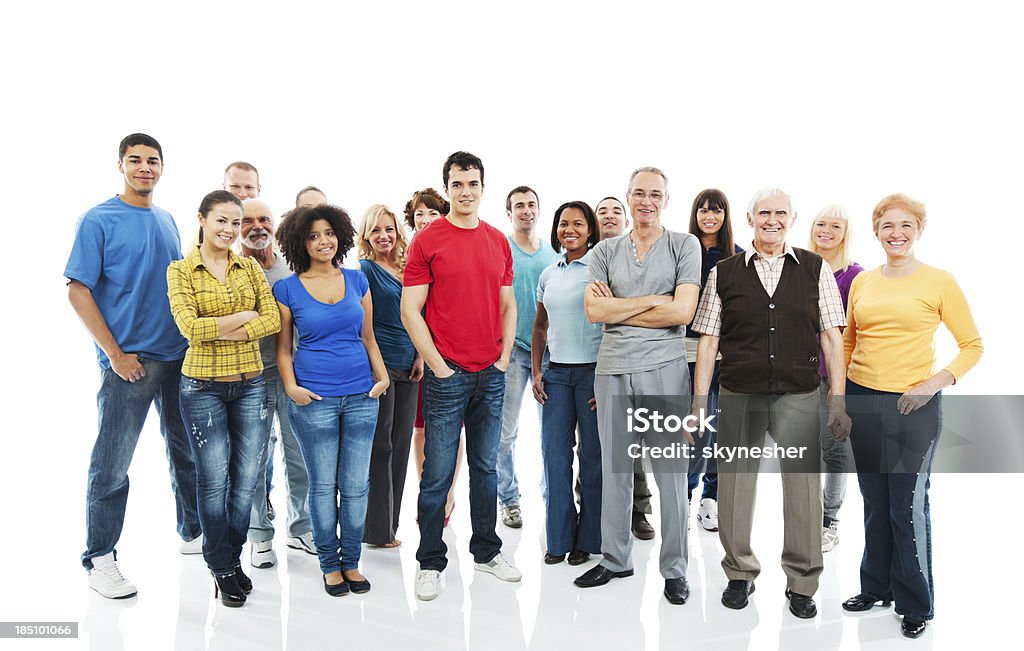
top-left (537, 251), bottom-right (601, 364)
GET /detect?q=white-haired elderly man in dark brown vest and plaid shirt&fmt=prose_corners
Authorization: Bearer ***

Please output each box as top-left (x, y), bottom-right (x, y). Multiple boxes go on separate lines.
top-left (693, 188), bottom-right (850, 618)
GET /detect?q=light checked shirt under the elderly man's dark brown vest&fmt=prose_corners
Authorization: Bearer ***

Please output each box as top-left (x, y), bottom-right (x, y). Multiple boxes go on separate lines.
top-left (693, 245), bottom-right (846, 337)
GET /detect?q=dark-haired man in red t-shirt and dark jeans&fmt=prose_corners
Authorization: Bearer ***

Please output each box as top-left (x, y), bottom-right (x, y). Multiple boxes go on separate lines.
top-left (401, 151), bottom-right (522, 601)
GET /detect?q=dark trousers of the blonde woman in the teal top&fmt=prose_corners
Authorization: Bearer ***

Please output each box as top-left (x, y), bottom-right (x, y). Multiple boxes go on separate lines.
top-left (362, 368), bottom-right (419, 545)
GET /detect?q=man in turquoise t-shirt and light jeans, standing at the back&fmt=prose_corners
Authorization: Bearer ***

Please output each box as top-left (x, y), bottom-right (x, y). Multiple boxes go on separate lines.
top-left (498, 185), bottom-right (558, 528)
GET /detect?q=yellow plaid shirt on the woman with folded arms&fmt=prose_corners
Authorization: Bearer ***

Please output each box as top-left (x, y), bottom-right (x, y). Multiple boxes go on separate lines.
top-left (167, 247), bottom-right (281, 378)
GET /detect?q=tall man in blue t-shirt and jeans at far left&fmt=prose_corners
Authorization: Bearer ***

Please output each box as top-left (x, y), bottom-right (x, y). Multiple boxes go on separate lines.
top-left (65, 133), bottom-right (202, 599)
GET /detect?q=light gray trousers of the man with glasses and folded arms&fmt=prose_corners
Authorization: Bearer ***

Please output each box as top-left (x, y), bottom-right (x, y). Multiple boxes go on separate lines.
top-left (594, 357), bottom-right (690, 578)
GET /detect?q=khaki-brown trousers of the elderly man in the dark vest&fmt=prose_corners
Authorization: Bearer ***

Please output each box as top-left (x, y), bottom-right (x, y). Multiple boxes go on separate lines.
top-left (718, 387), bottom-right (823, 596)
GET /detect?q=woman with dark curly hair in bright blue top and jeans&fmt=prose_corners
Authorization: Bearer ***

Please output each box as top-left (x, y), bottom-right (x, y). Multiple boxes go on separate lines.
top-left (273, 204), bottom-right (388, 597)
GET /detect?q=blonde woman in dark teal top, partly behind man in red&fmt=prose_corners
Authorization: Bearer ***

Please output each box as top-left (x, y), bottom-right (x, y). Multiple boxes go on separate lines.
top-left (357, 204), bottom-right (423, 549)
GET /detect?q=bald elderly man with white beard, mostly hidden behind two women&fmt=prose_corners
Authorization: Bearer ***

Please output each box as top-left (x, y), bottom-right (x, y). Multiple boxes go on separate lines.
top-left (241, 199), bottom-right (316, 569)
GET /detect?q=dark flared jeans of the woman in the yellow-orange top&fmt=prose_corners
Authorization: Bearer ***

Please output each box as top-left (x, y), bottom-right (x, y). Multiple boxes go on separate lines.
top-left (846, 380), bottom-right (942, 620)
